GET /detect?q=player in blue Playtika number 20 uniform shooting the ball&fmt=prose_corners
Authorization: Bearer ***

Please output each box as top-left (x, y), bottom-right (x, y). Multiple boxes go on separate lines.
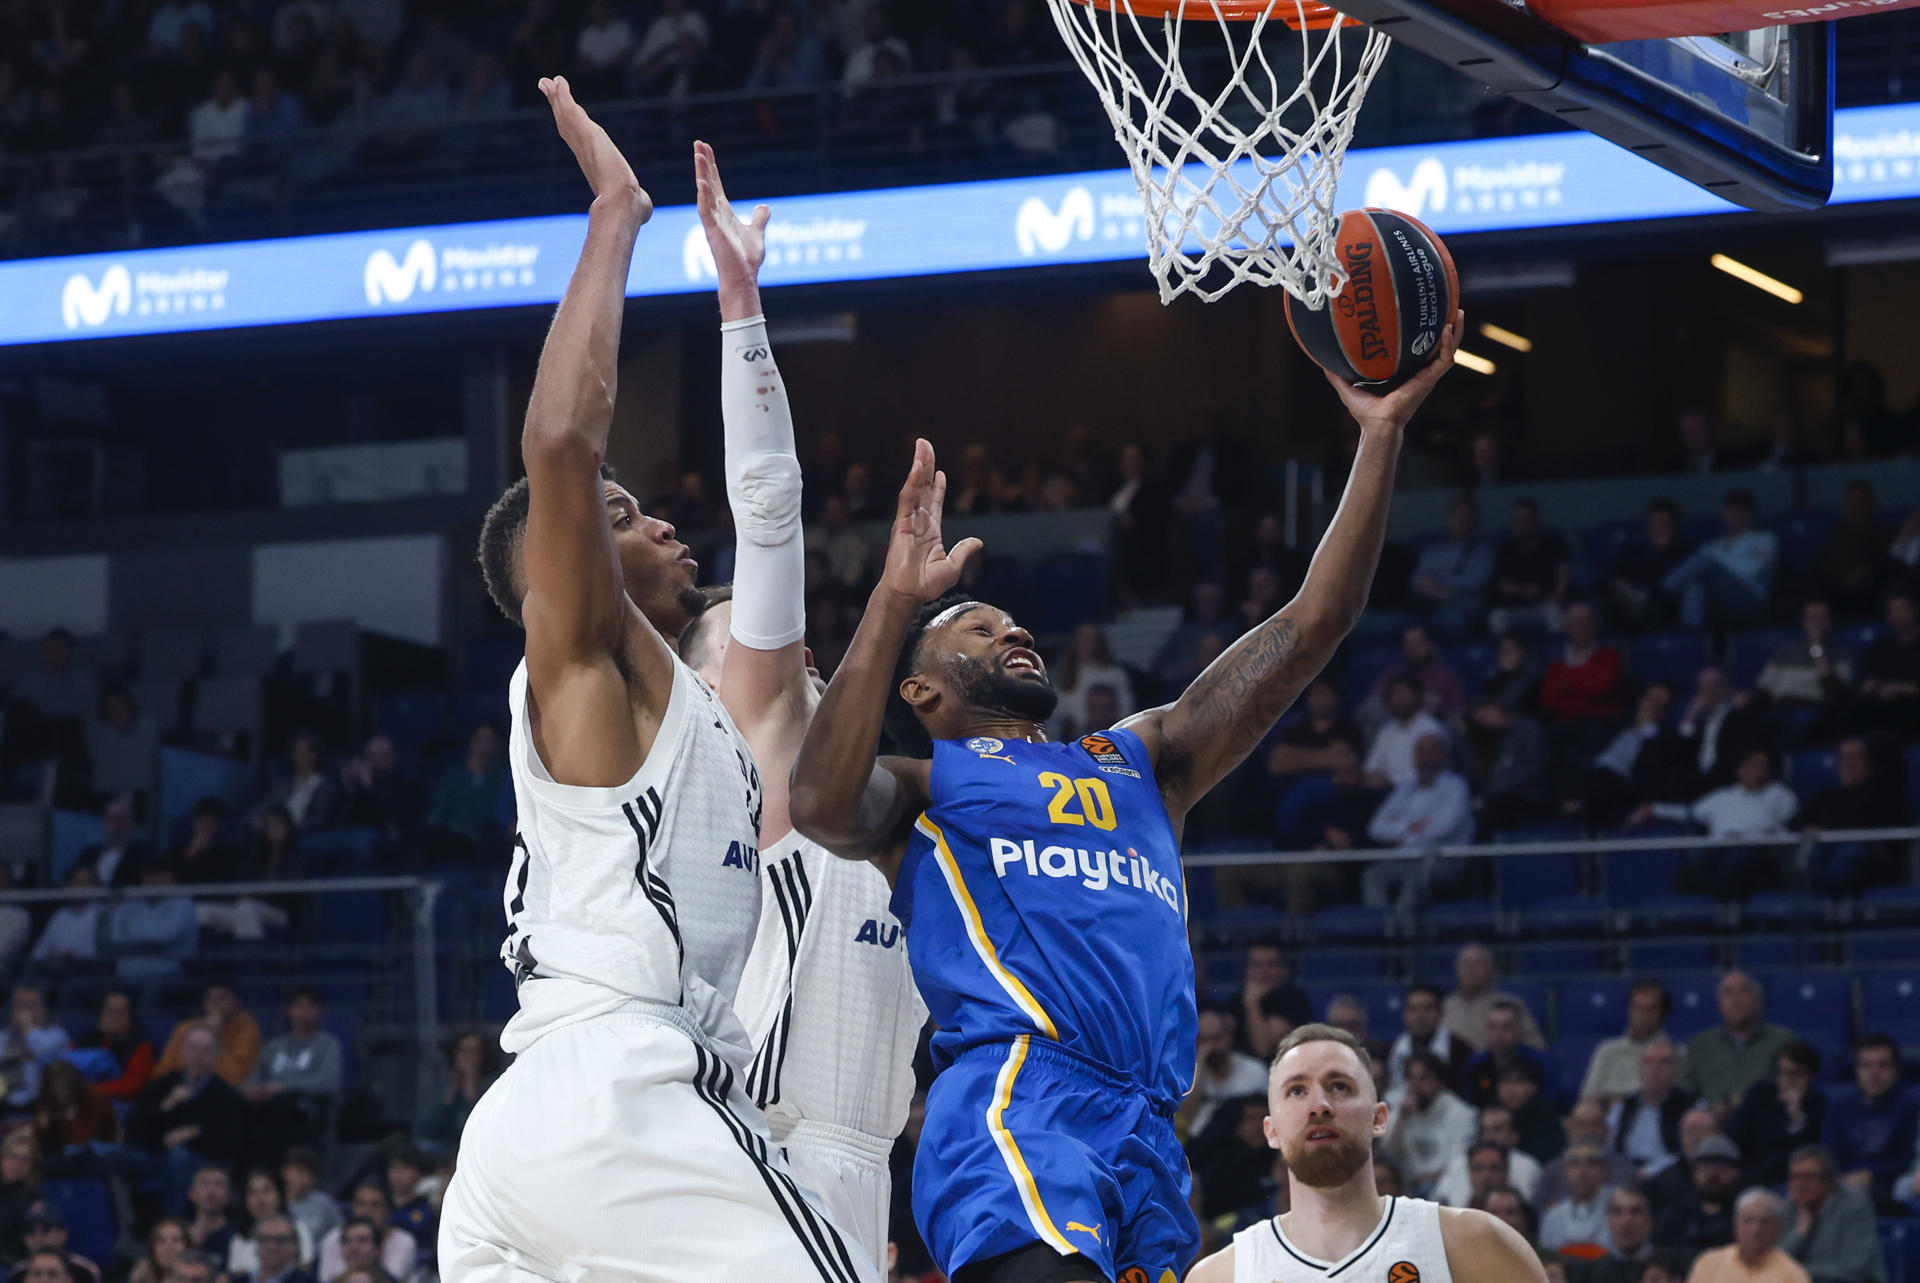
top-left (787, 322), bottom-right (1463, 1283)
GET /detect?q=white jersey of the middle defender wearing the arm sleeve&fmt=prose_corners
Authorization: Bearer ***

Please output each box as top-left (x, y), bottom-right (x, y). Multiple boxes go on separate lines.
top-left (739, 834), bottom-right (927, 1144)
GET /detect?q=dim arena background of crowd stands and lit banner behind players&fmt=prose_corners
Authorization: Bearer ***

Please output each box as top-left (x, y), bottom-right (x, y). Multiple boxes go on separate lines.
top-left (0, 0), bottom-right (1920, 1283)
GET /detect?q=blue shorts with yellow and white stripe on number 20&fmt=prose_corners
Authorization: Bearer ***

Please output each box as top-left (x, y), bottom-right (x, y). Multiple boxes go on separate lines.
top-left (914, 1037), bottom-right (1200, 1283)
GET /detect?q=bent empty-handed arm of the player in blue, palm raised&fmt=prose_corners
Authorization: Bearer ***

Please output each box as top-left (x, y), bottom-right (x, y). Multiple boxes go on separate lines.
top-left (787, 440), bottom-right (981, 876)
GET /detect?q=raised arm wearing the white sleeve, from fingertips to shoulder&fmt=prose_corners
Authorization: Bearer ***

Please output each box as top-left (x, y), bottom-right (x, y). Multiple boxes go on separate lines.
top-left (693, 142), bottom-right (818, 845)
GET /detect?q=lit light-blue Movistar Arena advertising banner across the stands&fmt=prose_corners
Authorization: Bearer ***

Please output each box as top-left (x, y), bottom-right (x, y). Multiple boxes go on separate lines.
top-left (0, 104), bottom-right (1920, 346)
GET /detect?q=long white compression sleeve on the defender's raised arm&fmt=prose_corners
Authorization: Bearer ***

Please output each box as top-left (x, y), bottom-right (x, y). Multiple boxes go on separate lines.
top-left (720, 317), bottom-right (806, 651)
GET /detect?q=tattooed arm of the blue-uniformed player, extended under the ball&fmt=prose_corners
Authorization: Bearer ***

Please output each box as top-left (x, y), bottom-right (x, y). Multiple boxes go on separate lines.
top-left (1121, 313), bottom-right (1465, 824)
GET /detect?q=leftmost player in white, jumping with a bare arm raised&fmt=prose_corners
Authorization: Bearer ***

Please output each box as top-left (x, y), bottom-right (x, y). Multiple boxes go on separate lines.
top-left (440, 79), bottom-right (877, 1283)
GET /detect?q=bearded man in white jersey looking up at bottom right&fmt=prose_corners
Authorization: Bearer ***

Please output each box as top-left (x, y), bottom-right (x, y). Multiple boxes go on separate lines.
top-left (1187, 1024), bottom-right (1548, 1283)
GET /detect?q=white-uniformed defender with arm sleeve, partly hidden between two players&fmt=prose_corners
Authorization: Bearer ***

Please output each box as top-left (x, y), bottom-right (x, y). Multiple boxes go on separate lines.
top-left (680, 142), bottom-right (927, 1273)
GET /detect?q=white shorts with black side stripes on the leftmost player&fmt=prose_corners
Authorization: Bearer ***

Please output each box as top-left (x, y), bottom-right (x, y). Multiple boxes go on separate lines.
top-left (440, 1005), bottom-right (881, 1283)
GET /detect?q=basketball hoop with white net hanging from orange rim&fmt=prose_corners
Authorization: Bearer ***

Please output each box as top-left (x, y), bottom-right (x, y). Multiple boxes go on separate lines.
top-left (1046, 0), bottom-right (1388, 309)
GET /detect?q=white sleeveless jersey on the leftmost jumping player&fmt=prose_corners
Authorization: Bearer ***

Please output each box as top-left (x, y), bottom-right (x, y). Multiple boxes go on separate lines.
top-left (501, 659), bottom-right (760, 1068)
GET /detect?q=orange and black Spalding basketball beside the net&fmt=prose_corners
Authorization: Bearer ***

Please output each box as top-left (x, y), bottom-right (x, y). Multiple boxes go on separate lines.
top-left (1286, 209), bottom-right (1459, 392)
